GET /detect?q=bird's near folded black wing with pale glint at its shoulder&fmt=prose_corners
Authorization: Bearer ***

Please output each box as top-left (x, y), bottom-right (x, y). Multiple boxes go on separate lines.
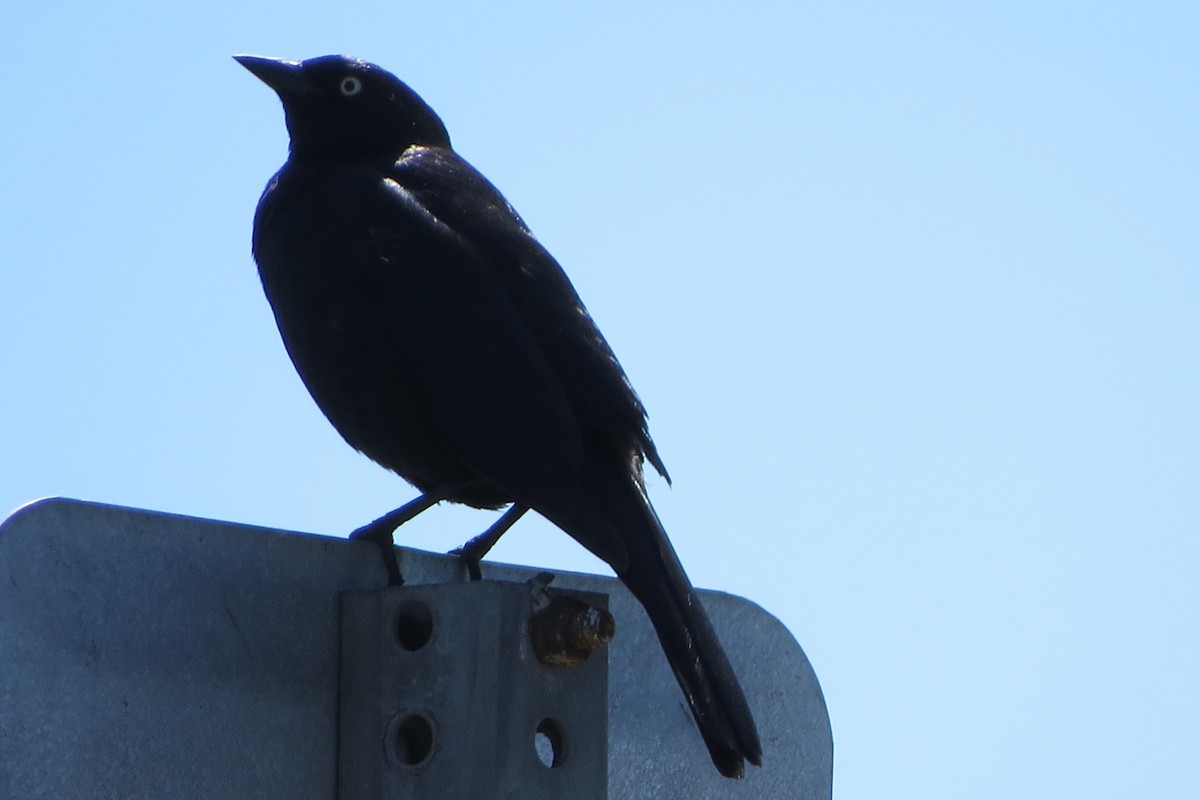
top-left (366, 170), bottom-right (592, 503)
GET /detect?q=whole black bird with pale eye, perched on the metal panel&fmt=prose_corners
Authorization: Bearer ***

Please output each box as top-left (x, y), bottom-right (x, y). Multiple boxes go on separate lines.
top-left (235, 55), bottom-right (762, 777)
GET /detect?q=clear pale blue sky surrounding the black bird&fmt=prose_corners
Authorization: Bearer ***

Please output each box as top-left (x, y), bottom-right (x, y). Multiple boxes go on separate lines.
top-left (0, 0), bottom-right (1200, 800)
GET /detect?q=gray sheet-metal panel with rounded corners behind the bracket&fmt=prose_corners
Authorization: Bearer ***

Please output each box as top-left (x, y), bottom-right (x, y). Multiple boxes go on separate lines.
top-left (0, 499), bottom-right (833, 800)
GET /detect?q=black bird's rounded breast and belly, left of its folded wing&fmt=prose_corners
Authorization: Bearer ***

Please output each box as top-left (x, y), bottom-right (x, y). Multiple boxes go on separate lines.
top-left (254, 160), bottom-right (510, 506)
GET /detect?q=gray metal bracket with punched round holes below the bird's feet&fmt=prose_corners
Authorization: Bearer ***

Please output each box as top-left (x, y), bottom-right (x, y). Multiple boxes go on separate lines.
top-left (337, 581), bottom-right (608, 800)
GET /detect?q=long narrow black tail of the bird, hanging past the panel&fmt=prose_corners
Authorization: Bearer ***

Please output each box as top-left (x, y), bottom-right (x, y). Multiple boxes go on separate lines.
top-left (547, 460), bottom-right (762, 777)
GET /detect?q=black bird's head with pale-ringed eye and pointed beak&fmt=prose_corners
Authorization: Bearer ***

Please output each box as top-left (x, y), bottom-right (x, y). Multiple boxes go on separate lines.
top-left (234, 55), bottom-right (450, 158)
